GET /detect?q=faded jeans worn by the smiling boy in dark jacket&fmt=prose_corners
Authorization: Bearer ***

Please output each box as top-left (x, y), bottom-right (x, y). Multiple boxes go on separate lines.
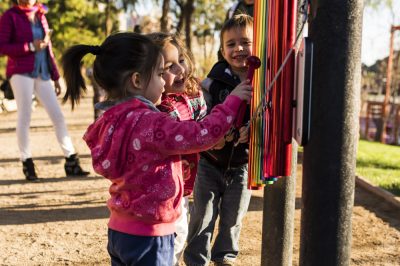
top-left (183, 158), bottom-right (251, 266)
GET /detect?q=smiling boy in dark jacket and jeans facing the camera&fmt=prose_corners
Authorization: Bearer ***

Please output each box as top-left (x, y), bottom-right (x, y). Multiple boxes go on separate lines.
top-left (184, 14), bottom-right (253, 265)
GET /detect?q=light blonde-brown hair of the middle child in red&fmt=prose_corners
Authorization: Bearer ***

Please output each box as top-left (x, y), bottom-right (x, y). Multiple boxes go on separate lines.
top-left (146, 32), bottom-right (200, 96)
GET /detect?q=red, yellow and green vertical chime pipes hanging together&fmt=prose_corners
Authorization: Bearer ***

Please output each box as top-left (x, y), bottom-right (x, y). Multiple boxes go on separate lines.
top-left (249, 0), bottom-right (297, 189)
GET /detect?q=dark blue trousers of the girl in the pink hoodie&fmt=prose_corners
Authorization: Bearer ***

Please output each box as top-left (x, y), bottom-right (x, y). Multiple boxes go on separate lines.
top-left (107, 229), bottom-right (175, 266)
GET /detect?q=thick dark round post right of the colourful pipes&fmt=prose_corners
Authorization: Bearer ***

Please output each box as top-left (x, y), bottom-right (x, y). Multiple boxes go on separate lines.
top-left (300, 0), bottom-right (363, 266)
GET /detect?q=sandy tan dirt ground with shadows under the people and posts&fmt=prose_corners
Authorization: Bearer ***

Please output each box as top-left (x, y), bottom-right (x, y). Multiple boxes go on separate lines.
top-left (0, 94), bottom-right (400, 265)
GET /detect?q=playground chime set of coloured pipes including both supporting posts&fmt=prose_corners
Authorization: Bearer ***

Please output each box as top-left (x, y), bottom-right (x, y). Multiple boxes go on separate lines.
top-left (249, 0), bottom-right (362, 266)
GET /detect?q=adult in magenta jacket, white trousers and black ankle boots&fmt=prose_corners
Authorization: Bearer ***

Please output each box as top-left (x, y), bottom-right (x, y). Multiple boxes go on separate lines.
top-left (0, 0), bottom-right (89, 181)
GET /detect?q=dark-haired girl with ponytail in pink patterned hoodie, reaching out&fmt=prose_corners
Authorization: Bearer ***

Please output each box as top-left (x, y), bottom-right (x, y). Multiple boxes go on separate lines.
top-left (62, 32), bottom-right (251, 265)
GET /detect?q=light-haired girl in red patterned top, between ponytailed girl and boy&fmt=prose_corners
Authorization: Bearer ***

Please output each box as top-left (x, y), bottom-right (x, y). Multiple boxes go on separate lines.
top-left (147, 32), bottom-right (207, 266)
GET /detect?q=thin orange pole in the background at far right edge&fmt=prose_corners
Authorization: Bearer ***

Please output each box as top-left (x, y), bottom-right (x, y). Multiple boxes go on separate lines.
top-left (380, 26), bottom-right (400, 143)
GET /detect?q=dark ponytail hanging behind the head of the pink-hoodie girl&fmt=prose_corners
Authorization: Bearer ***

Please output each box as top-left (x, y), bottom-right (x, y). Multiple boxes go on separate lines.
top-left (61, 45), bottom-right (101, 109)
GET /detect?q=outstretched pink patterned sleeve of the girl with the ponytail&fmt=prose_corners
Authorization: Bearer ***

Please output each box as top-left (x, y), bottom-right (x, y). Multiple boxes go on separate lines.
top-left (136, 95), bottom-right (242, 155)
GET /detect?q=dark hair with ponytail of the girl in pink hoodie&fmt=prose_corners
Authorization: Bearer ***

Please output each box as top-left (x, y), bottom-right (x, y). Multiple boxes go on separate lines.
top-left (62, 32), bottom-right (161, 109)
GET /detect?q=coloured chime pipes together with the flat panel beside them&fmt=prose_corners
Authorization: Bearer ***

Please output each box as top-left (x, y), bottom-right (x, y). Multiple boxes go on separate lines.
top-left (248, 1), bottom-right (313, 189)
